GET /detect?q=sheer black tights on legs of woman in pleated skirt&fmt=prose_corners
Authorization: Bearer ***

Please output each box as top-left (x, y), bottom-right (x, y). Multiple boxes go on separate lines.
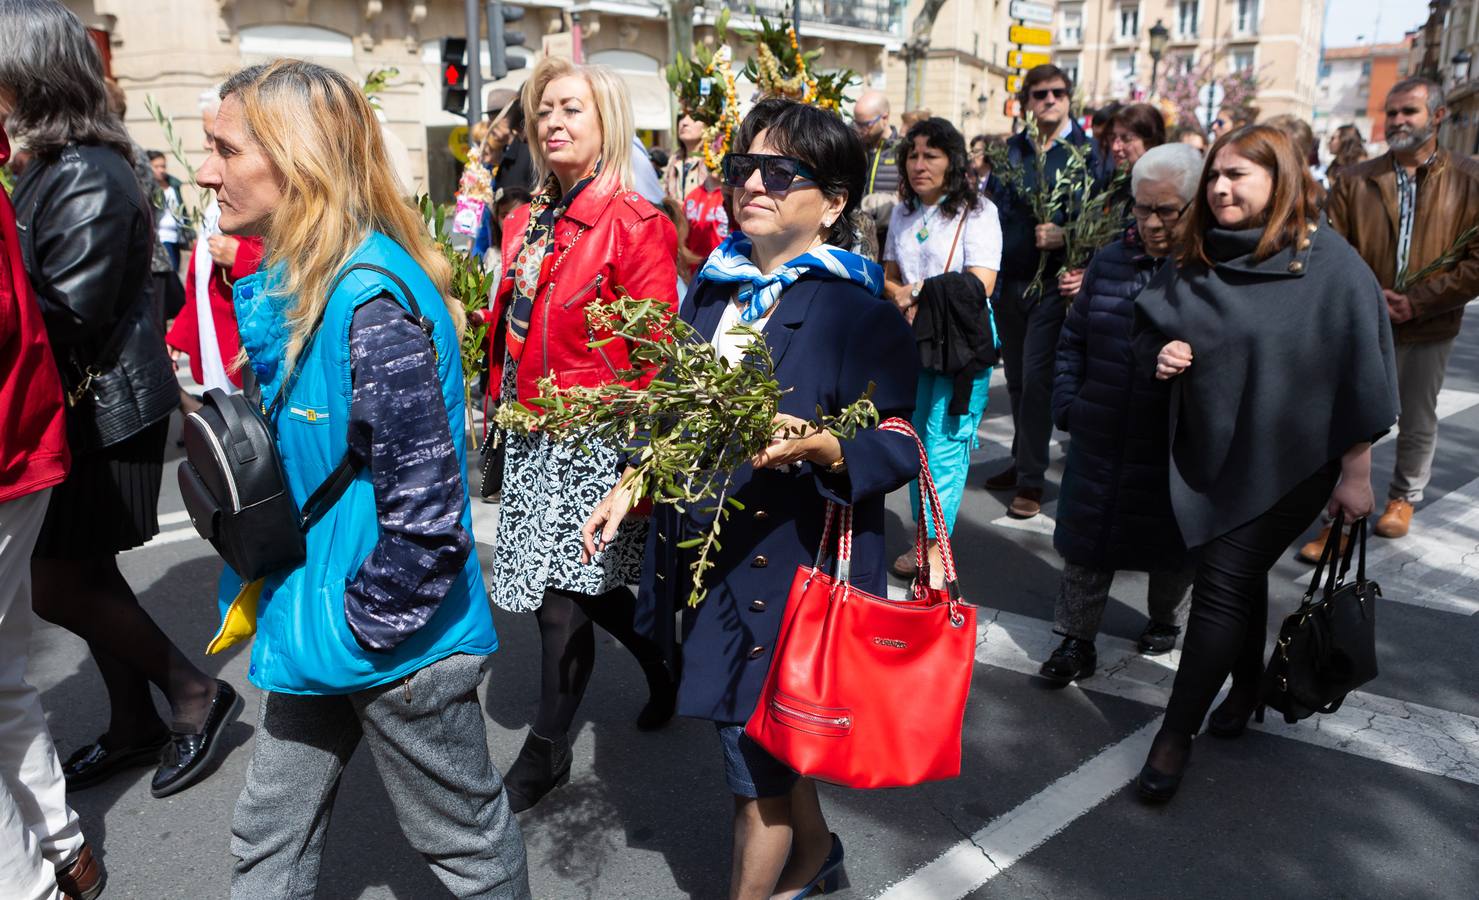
top-left (31, 556), bottom-right (216, 746)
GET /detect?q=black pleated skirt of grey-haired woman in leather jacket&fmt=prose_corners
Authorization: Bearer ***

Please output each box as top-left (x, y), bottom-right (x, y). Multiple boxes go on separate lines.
top-left (31, 417), bottom-right (170, 559)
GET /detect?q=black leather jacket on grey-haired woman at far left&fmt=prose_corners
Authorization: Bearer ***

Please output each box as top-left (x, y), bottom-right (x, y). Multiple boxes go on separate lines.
top-left (12, 143), bottom-right (179, 455)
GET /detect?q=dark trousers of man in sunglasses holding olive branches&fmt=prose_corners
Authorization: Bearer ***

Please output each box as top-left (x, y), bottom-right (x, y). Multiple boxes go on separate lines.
top-left (994, 280), bottom-right (1068, 489)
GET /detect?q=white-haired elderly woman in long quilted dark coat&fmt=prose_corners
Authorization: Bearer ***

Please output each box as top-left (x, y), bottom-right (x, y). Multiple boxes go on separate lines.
top-left (1040, 144), bottom-right (1202, 684)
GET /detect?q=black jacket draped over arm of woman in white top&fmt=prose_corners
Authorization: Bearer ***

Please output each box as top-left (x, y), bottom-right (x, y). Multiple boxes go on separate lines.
top-left (914, 272), bottom-right (997, 415)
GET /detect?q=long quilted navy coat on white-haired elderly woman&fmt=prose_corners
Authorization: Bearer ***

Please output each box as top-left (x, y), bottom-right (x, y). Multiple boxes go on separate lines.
top-left (1053, 236), bottom-right (1186, 572)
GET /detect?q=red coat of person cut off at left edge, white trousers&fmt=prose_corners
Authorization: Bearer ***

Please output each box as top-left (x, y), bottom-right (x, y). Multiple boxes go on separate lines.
top-left (0, 129), bottom-right (71, 502)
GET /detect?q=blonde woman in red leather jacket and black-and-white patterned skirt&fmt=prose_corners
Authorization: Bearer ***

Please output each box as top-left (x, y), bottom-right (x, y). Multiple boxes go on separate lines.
top-left (490, 59), bottom-right (677, 813)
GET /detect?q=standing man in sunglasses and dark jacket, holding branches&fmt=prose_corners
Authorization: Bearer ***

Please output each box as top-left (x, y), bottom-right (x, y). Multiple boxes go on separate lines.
top-left (986, 65), bottom-right (1097, 519)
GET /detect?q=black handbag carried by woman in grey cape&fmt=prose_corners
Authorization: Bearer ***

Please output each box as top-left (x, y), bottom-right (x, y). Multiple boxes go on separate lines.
top-left (1263, 516), bottom-right (1381, 724)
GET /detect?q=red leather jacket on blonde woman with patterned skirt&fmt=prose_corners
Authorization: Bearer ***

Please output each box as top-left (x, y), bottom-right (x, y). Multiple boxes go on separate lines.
top-left (490, 182), bottom-right (679, 402)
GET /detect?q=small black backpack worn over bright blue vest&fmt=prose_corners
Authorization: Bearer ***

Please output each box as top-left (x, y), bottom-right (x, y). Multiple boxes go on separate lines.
top-left (179, 263), bottom-right (432, 582)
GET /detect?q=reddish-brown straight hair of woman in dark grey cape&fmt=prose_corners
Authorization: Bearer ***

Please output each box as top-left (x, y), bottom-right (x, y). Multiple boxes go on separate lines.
top-left (1176, 126), bottom-right (1319, 267)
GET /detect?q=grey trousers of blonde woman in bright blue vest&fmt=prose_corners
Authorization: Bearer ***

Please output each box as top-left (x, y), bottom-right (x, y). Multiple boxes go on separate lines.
top-left (231, 655), bottom-right (529, 900)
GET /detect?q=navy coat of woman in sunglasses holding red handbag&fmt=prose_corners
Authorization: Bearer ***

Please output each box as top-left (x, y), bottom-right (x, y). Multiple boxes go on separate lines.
top-left (637, 273), bottom-right (918, 723)
